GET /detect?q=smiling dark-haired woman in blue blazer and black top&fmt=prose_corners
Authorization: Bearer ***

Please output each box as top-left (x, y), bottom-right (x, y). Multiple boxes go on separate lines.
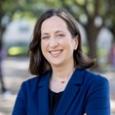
top-left (13, 9), bottom-right (110, 115)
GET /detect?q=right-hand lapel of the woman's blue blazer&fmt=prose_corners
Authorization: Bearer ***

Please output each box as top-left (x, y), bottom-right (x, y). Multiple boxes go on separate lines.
top-left (55, 69), bottom-right (83, 115)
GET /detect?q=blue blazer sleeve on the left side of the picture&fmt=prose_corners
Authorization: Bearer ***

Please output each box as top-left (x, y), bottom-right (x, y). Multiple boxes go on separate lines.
top-left (12, 83), bottom-right (27, 115)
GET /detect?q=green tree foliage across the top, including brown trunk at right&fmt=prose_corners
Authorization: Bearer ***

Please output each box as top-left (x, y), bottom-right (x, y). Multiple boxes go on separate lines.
top-left (0, 0), bottom-right (115, 68)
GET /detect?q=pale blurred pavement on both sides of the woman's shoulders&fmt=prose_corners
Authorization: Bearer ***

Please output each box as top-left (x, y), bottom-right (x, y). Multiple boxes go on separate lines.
top-left (0, 58), bottom-right (115, 115)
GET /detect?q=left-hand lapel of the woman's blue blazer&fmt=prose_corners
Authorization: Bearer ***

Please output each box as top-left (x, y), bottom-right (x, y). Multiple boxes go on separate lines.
top-left (38, 73), bottom-right (50, 115)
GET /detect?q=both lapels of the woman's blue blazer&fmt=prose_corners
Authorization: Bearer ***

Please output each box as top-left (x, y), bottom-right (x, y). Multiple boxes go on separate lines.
top-left (38, 69), bottom-right (84, 115)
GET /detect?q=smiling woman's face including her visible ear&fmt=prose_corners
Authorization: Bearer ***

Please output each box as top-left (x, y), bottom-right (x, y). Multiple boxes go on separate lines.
top-left (41, 16), bottom-right (78, 66)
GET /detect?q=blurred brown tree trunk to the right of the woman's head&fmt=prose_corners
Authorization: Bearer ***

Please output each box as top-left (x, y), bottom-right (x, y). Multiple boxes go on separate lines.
top-left (86, 20), bottom-right (100, 70)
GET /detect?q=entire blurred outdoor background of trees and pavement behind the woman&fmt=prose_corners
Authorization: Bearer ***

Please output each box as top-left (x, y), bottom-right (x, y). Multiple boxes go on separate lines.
top-left (0, 0), bottom-right (115, 115)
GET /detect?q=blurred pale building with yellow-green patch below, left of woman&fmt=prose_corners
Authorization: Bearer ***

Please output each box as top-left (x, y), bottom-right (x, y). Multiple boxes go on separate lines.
top-left (3, 20), bottom-right (34, 56)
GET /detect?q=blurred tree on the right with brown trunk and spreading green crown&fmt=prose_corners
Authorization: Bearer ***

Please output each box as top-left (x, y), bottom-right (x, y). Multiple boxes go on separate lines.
top-left (60, 0), bottom-right (115, 66)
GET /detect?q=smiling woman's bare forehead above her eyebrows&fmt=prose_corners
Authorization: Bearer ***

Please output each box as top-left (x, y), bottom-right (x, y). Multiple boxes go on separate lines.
top-left (41, 16), bottom-right (68, 33)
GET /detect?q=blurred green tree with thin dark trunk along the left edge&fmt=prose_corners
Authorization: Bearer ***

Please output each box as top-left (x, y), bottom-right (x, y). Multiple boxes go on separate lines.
top-left (0, 0), bottom-right (41, 93)
